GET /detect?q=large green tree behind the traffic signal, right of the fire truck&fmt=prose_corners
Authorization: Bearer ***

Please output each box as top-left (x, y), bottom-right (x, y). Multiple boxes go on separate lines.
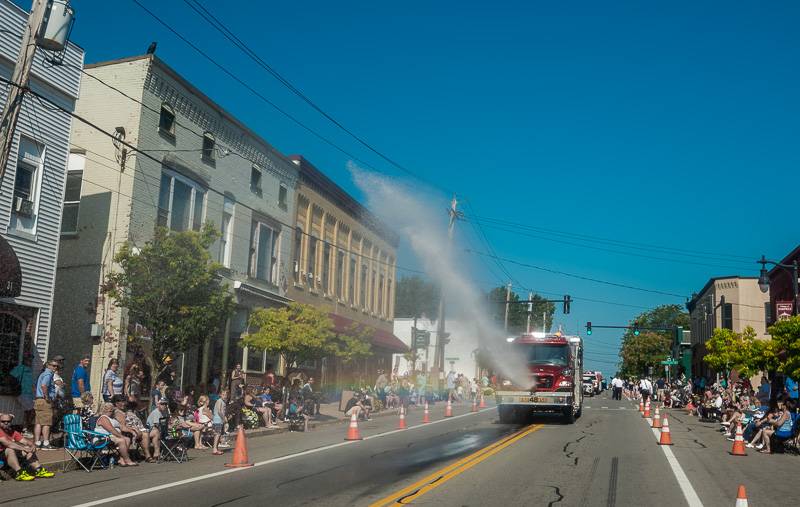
top-left (619, 305), bottom-right (689, 376)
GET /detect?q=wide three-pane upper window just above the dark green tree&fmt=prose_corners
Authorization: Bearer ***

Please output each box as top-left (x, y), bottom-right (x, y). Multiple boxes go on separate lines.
top-left (157, 171), bottom-right (206, 231)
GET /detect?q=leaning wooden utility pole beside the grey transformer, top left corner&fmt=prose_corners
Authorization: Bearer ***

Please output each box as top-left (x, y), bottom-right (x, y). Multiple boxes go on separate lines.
top-left (0, 0), bottom-right (48, 181)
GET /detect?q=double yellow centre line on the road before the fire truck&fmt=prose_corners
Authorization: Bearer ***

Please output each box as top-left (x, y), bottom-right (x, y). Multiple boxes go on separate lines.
top-left (370, 424), bottom-right (544, 507)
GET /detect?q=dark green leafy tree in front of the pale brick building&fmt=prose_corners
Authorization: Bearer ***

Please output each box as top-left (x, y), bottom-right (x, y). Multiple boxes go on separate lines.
top-left (102, 224), bottom-right (233, 366)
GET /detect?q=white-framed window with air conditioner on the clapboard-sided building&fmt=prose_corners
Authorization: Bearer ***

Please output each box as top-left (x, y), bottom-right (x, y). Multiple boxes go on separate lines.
top-left (11, 137), bottom-right (44, 234)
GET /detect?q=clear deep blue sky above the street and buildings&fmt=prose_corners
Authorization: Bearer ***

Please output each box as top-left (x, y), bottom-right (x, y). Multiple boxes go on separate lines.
top-left (39, 0), bottom-right (800, 373)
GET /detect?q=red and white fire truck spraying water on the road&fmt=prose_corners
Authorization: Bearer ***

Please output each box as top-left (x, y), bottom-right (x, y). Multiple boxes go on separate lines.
top-left (495, 331), bottom-right (583, 423)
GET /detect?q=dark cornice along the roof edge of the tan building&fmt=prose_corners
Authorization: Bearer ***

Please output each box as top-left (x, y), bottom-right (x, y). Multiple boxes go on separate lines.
top-left (287, 155), bottom-right (399, 248)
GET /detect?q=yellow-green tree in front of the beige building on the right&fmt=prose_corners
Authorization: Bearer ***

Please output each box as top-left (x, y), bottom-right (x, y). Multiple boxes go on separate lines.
top-left (703, 326), bottom-right (772, 377)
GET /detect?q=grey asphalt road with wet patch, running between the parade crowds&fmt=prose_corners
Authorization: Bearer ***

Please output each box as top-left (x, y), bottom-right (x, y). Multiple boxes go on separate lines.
top-left (0, 395), bottom-right (797, 506)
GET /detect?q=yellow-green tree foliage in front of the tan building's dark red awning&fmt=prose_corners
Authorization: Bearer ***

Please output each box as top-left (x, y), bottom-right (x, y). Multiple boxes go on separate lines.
top-left (242, 303), bottom-right (371, 376)
